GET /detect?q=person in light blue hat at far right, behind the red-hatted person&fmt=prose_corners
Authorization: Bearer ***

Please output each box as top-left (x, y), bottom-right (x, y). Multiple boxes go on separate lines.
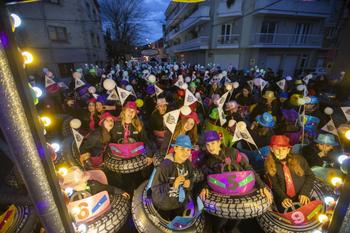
top-left (302, 133), bottom-right (339, 167)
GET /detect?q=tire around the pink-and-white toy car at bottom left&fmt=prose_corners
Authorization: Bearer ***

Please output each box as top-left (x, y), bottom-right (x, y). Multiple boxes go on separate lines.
top-left (87, 194), bottom-right (130, 233)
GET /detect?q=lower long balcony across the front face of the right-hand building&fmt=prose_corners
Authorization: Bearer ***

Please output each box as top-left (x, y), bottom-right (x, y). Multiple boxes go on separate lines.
top-left (251, 33), bottom-right (323, 48)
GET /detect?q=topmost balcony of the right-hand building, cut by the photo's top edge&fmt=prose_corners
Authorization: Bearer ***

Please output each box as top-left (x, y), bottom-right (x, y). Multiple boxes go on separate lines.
top-left (255, 0), bottom-right (332, 17)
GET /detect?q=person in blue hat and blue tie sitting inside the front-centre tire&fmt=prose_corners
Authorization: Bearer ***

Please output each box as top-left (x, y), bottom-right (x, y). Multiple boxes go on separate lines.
top-left (151, 135), bottom-right (193, 221)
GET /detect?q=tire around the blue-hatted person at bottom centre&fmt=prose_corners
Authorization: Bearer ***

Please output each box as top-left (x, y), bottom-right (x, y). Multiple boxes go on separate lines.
top-left (131, 181), bottom-right (206, 233)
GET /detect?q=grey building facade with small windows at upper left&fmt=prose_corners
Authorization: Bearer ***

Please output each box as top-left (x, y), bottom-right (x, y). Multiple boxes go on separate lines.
top-left (9, 0), bottom-right (106, 77)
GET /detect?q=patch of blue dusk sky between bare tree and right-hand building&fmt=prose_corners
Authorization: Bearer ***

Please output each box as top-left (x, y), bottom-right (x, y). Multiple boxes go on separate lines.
top-left (144, 0), bottom-right (171, 43)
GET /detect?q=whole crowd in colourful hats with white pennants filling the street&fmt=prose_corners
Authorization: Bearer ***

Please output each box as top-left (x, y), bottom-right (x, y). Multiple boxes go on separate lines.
top-left (35, 62), bottom-right (344, 232)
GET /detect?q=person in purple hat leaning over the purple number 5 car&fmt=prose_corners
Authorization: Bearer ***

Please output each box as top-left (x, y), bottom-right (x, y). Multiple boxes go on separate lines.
top-left (200, 131), bottom-right (272, 232)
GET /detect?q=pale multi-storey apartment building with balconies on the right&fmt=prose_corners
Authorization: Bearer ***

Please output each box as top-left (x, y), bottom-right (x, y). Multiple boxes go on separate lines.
top-left (165, 0), bottom-right (343, 75)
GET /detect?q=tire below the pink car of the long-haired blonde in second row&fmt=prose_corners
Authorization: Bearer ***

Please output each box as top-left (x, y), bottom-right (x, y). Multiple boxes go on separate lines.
top-left (104, 153), bottom-right (152, 174)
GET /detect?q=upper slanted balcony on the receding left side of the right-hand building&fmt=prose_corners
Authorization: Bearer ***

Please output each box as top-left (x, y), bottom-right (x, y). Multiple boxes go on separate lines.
top-left (167, 6), bottom-right (210, 40)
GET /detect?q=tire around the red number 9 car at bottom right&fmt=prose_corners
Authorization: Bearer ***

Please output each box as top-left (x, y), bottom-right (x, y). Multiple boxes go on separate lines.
top-left (257, 180), bottom-right (333, 233)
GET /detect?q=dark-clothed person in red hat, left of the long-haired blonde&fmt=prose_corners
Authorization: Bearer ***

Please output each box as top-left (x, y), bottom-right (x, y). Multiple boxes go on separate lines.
top-left (80, 112), bottom-right (116, 167)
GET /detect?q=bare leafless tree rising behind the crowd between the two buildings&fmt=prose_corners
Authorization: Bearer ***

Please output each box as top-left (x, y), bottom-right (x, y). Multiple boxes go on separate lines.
top-left (99, 0), bottom-right (145, 62)
